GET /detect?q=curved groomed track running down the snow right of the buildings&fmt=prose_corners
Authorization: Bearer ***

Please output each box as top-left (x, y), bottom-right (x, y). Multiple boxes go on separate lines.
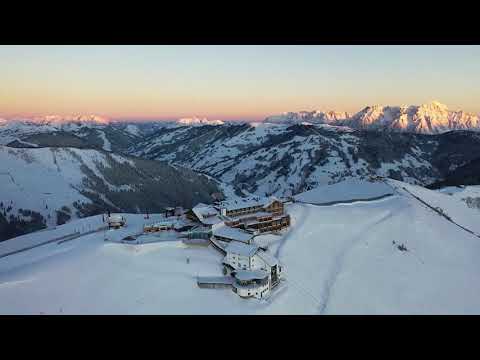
top-left (319, 206), bottom-right (408, 315)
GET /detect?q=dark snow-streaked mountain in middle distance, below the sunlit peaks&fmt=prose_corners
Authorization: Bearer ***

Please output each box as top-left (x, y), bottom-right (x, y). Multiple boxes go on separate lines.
top-left (130, 123), bottom-right (480, 196)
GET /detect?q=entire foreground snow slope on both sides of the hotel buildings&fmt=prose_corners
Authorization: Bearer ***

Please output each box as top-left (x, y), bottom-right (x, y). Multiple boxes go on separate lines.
top-left (0, 182), bottom-right (480, 314)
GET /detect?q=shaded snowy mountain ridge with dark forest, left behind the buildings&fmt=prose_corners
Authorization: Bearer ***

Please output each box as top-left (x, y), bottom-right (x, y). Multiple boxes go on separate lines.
top-left (0, 146), bottom-right (220, 240)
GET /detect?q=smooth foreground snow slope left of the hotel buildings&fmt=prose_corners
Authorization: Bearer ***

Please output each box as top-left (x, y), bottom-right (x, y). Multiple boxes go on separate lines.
top-left (0, 216), bottom-right (265, 314)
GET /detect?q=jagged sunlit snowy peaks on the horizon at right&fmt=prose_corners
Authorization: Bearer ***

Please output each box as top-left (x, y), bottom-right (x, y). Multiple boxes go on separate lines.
top-left (265, 101), bottom-right (480, 134)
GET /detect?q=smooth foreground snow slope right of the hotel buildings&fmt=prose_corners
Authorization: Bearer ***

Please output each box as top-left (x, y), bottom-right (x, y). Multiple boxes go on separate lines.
top-left (278, 193), bottom-right (480, 314)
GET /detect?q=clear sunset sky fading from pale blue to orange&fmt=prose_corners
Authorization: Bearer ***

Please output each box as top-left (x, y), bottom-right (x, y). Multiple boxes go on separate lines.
top-left (0, 45), bottom-right (480, 120)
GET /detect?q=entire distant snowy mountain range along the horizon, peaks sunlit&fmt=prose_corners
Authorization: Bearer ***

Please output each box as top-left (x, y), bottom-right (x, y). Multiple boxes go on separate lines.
top-left (0, 101), bottom-right (480, 135)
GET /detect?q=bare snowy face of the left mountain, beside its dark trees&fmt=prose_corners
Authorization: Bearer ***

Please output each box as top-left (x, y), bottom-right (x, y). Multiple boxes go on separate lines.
top-left (0, 146), bottom-right (98, 226)
